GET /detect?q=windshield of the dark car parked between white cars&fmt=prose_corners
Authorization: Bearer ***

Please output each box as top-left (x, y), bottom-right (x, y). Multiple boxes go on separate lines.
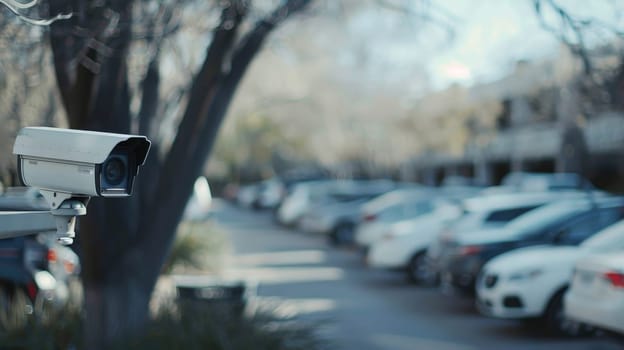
top-left (505, 204), bottom-right (583, 234)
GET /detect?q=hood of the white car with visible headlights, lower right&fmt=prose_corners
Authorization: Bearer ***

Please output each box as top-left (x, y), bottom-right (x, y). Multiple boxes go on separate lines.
top-left (485, 246), bottom-right (588, 273)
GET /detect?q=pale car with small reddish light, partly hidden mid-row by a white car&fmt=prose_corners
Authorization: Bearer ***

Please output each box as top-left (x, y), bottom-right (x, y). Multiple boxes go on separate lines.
top-left (355, 187), bottom-right (437, 248)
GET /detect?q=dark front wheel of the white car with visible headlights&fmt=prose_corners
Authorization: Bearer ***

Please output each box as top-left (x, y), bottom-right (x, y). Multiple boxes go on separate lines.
top-left (544, 289), bottom-right (594, 337)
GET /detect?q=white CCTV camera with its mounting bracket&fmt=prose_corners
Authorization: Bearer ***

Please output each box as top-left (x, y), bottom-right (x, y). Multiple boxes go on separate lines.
top-left (13, 127), bottom-right (150, 244)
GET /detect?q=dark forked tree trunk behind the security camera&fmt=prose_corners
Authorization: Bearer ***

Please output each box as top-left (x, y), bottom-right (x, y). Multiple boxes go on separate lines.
top-left (45, 0), bottom-right (310, 349)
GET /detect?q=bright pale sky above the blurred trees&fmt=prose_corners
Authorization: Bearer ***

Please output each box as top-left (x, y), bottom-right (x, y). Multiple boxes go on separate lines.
top-left (349, 0), bottom-right (621, 90)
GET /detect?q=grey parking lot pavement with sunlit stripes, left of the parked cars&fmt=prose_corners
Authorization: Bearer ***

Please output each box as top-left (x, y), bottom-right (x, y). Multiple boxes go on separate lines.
top-left (214, 202), bottom-right (621, 350)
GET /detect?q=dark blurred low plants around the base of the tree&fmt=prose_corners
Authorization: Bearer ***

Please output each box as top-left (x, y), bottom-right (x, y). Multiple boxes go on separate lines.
top-left (0, 301), bottom-right (327, 350)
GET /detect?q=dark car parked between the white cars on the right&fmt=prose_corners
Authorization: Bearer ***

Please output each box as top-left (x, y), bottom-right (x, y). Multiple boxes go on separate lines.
top-left (440, 198), bottom-right (624, 294)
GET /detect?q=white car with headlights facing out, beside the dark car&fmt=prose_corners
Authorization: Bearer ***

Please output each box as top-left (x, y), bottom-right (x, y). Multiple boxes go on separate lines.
top-left (476, 221), bottom-right (624, 335)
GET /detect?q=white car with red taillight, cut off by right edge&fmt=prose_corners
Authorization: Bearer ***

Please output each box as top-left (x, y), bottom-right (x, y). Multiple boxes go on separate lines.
top-left (564, 251), bottom-right (624, 335)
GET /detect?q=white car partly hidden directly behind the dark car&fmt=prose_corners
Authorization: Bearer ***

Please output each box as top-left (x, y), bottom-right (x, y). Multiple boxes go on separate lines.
top-left (426, 191), bottom-right (585, 280)
